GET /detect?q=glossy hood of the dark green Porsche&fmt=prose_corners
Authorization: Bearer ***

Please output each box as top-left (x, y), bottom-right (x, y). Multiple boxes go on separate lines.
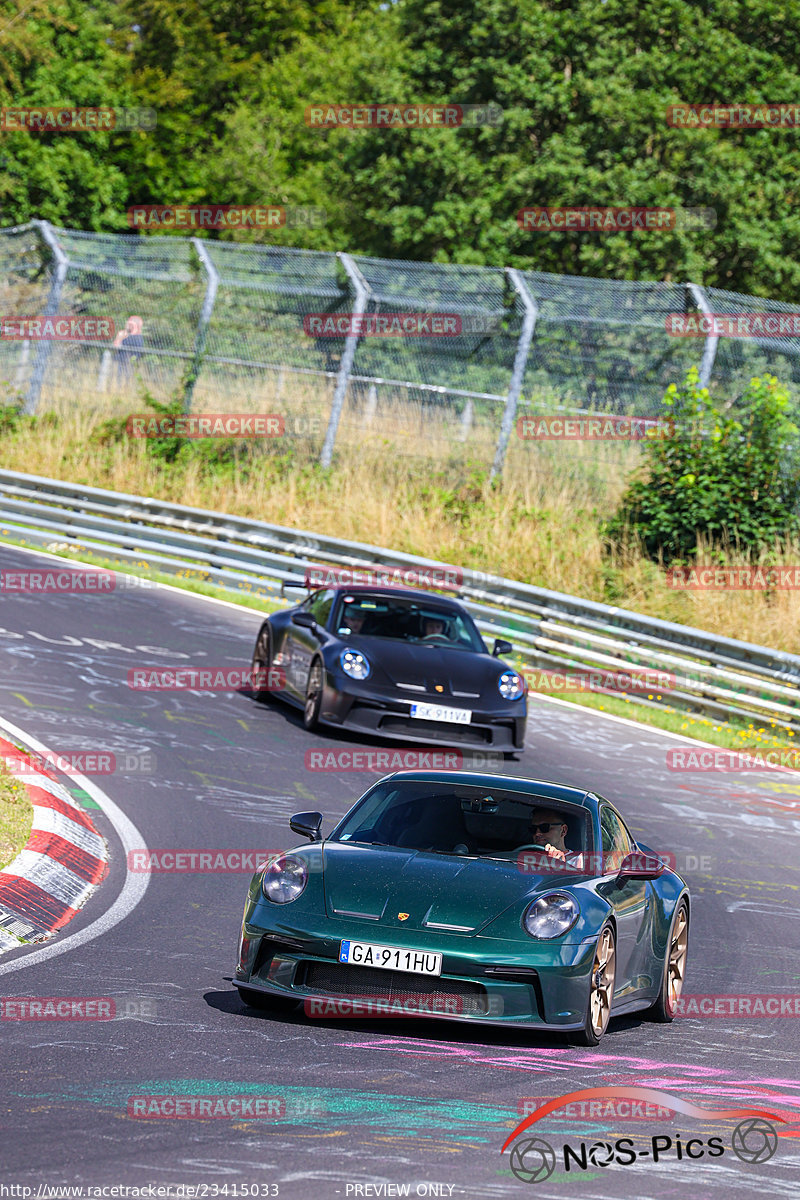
top-left (323, 842), bottom-right (561, 934)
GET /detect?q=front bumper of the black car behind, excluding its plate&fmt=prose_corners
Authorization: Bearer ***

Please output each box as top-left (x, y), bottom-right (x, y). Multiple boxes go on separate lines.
top-left (320, 674), bottom-right (527, 751)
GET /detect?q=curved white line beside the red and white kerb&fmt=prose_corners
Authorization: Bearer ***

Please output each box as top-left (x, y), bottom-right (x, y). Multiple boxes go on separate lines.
top-left (0, 716), bottom-right (150, 974)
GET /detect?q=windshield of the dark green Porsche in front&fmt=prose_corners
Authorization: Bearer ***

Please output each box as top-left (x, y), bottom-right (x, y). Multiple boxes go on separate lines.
top-left (331, 780), bottom-right (594, 862)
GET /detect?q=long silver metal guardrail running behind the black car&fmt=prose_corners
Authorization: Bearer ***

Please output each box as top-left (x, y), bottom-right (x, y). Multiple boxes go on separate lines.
top-left (0, 470), bottom-right (800, 733)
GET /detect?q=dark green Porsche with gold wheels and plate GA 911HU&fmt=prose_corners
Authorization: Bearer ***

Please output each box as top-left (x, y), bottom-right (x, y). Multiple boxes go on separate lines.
top-left (234, 772), bottom-right (690, 1045)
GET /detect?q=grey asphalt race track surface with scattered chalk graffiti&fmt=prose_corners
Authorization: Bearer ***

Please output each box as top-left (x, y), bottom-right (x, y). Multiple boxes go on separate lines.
top-left (0, 546), bottom-right (800, 1200)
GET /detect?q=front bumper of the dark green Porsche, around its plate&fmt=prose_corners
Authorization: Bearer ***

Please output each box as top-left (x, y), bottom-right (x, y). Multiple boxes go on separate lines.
top-left (234, 918), bottom-right (595, 1033)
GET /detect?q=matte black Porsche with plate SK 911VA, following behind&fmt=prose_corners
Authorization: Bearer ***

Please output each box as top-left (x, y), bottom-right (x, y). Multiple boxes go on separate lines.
top-left (252, 586), bottom-right (527, 752)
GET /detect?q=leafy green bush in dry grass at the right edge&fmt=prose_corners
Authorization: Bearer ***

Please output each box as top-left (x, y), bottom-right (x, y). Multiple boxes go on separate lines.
top-left (604, 367), bottom-right (800, 562)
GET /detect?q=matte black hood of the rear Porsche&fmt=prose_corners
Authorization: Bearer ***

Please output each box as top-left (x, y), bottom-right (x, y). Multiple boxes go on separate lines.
top-left (345, 637), bottom-right (509, 698)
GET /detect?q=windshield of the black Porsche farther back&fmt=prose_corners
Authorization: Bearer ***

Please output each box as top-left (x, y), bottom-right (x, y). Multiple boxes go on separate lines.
top-left (333, 593), bottom-right (486, 654)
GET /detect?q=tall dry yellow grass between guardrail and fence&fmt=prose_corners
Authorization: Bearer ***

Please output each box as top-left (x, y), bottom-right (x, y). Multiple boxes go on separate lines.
top-left (0, 380), bottom-right (800, 652)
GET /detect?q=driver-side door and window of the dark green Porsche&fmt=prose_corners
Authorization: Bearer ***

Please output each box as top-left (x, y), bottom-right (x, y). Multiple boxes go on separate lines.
top-left (597, 804), bottom-right (652, 1000)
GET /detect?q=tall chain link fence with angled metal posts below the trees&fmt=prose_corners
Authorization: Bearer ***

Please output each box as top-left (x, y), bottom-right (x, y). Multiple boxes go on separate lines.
top-left (0, 221), bottom-right (800, 474)
